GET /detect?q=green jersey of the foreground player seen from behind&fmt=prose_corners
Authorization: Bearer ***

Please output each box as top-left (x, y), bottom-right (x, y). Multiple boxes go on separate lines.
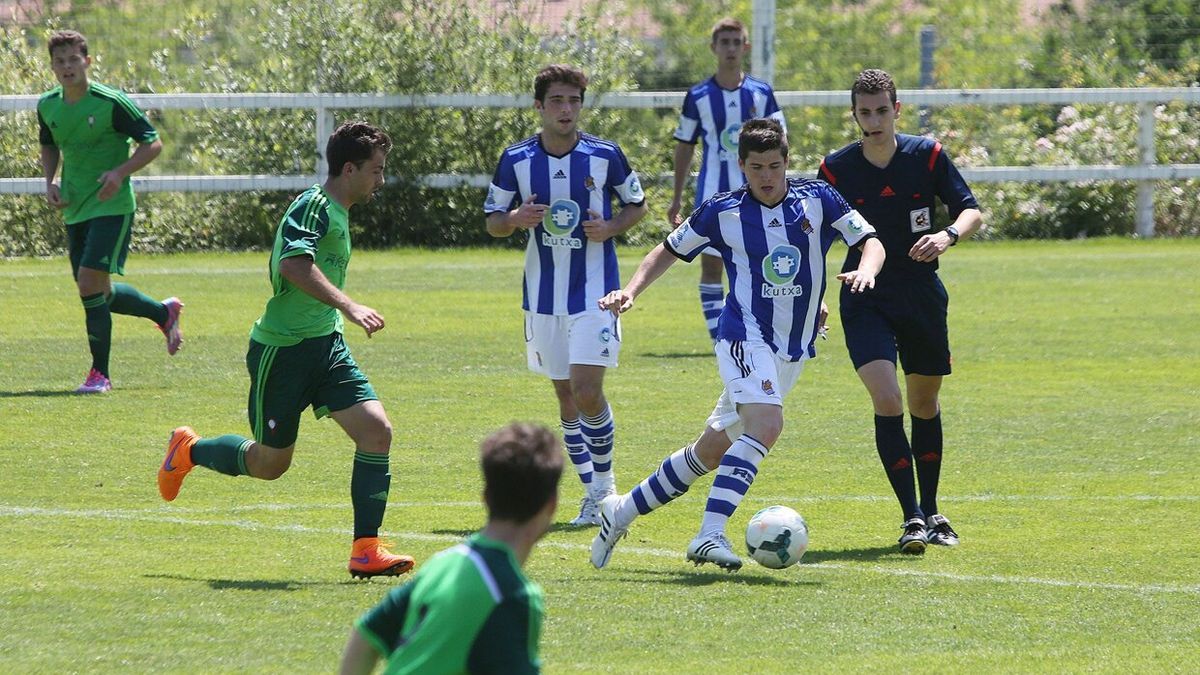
top-left (355, 533), bottom-right (544, 674)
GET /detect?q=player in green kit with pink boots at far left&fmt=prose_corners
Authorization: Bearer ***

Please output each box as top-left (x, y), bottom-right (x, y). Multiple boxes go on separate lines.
top-left (37, 30), bottom-right (184, 394)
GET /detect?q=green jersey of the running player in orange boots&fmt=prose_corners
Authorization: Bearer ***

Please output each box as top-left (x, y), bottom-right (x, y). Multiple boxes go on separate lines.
top-left (250, 185), bottom-right (350, 347)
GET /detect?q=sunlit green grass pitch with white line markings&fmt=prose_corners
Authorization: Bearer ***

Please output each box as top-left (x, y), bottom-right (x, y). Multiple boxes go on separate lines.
top-left (0, 240), bottom-right (1200, 673)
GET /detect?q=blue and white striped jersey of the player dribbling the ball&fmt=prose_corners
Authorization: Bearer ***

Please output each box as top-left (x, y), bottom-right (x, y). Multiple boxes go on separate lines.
top-left (665, 178), bottom-right (875, 362)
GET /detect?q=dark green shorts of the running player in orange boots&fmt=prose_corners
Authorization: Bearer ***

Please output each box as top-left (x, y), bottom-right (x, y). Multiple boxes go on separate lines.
top-left (246, 333), bottom-right (379, 448)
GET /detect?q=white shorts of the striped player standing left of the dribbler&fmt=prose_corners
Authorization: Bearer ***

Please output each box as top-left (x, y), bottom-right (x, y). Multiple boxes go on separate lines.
top-left (526, 309), bottom-right (620, 380)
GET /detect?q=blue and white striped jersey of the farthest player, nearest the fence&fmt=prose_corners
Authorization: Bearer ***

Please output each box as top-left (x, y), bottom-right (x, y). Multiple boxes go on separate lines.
top-left (674, 74), bottom-right (787, 207)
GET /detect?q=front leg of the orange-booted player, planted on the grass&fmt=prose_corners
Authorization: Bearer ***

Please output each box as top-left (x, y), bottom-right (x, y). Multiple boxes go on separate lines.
top-left (313, 333), bottom-right (414, 578)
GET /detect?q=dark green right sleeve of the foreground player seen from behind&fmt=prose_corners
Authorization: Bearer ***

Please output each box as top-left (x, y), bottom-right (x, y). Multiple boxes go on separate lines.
top-left (467, 593), bottom-right (541, 674)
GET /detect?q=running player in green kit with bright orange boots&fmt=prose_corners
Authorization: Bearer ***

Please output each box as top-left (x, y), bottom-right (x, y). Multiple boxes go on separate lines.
top-left (158, 121), bottom-right (413, 577)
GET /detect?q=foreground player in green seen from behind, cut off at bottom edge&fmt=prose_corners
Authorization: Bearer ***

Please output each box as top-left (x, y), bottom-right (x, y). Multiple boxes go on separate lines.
top-left (341, 423), bottom-right (563, 675)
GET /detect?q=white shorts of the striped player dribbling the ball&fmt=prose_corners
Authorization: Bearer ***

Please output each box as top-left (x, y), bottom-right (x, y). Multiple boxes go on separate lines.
top-left (707, 340), bottom-right (806, 441)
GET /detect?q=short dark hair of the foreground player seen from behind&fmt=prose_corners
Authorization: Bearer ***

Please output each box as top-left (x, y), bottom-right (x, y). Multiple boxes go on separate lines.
top-left (479, 422), bottom-right (563, 522)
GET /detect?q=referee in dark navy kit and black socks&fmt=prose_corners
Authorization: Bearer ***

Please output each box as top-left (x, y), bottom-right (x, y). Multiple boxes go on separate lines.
top-left (817, 68), bottom-right (983, 554)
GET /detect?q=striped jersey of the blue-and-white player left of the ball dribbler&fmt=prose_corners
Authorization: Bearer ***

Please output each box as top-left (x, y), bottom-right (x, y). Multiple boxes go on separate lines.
top-left (484, 133), bottom-right (646, 315)
